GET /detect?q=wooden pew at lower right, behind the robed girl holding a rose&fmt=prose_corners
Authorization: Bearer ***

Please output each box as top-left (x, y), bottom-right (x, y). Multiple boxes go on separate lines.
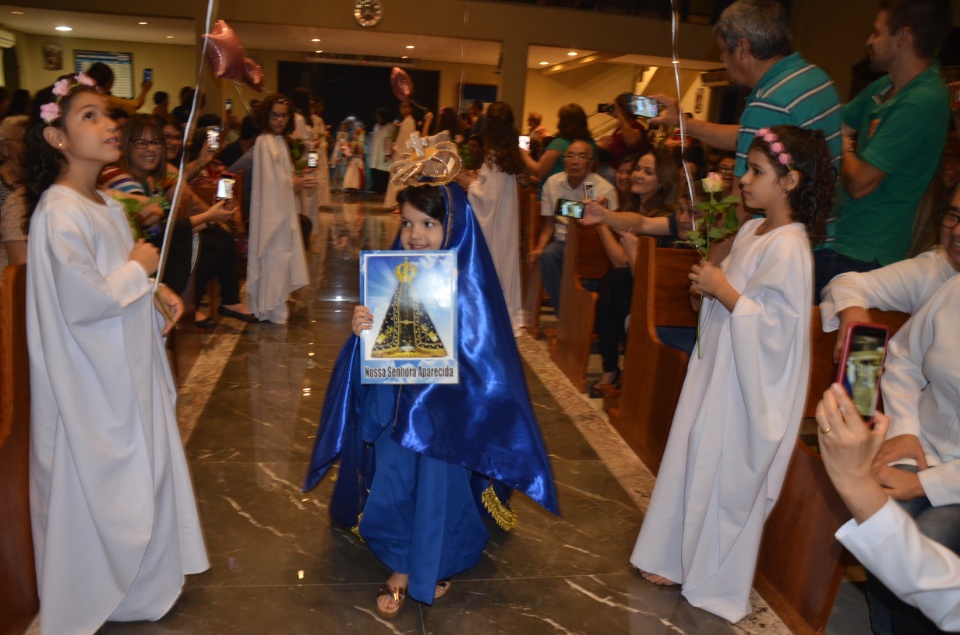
top-left (755, 307), bottom-right (909, 633)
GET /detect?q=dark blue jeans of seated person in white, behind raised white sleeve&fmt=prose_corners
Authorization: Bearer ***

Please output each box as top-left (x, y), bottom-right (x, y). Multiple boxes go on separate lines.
top-left (867, 465), bottom-right (960, 635)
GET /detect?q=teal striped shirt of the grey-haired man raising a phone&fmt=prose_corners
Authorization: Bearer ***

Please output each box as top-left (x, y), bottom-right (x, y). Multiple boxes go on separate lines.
top-left (734, 53), bottom-right (841, 177)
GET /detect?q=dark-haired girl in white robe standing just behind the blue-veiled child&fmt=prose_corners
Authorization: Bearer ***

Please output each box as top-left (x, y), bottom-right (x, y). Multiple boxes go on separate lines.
top-left (459, 101), bottom-right (523, 336)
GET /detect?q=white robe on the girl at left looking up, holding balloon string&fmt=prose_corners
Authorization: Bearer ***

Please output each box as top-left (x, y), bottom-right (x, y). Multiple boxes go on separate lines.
top-left (27, 185), bottom-right (209, 635)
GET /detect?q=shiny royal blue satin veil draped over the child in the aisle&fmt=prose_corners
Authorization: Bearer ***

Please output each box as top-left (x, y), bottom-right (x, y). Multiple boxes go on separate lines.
top-left (304, 181), bottom-right (558, 526)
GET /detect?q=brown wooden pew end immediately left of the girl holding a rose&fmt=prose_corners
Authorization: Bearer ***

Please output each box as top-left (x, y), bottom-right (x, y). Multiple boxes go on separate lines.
top-left (604, 236), bottom-right (700, 474)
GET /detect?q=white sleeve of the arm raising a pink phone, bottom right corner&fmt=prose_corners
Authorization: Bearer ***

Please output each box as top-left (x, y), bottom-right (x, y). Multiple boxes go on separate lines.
top-left (836, 500), bottom-right (960, 631)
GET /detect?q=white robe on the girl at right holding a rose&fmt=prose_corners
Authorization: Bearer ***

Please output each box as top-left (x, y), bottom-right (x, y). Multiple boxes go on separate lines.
top-left (630, 219), bottom-right (813, 622)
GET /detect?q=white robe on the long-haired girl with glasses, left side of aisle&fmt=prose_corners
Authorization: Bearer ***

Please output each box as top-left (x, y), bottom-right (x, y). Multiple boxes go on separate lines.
top-left (247, 134), bottom-right (310, 324)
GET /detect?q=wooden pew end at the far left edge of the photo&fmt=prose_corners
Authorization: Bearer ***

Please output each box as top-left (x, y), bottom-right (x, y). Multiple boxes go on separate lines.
top-left (0, 265), bottom-right (40, 633)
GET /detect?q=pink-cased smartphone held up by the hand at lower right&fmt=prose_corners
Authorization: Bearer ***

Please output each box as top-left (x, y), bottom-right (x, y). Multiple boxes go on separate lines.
top-left (837, 322), bottom-right (890, 421)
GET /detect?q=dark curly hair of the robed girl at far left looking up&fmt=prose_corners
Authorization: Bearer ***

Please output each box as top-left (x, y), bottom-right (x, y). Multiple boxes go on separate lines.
top-left (24, 82), bottom-right (99, 214)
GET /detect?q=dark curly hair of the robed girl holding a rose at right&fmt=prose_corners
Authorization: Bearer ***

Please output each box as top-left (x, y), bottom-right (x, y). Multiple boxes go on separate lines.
top-left (750, 126), bottom-right (837, 245)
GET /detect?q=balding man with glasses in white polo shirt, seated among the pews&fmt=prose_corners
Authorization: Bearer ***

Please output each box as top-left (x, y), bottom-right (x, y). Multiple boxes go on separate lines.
top-left (527, 139), bottom-right (619, 316)
